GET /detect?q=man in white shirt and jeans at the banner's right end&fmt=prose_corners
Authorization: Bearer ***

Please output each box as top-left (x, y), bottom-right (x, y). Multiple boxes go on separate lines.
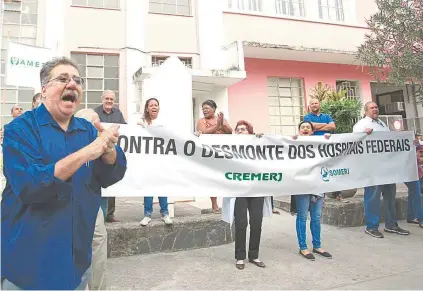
top-left (353, 101), bottom-right (410, 238)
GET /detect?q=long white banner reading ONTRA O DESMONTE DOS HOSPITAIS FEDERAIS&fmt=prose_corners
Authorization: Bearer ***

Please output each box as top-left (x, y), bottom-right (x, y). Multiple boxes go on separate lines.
top-left (103, 125), bottom-right (418, 197)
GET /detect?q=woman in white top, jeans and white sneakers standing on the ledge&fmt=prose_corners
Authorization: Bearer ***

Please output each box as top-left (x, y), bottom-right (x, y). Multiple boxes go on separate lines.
top-left (138, 98), bottom-right (173, 226)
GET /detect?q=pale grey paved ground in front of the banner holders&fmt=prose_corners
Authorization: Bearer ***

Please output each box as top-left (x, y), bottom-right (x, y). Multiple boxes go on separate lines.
top-left (108, 209), bottom-right (423, 290)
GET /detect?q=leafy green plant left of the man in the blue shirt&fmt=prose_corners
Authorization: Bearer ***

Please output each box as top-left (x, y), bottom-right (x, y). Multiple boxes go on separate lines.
top-left (321, 98), bottom-right (362, 133)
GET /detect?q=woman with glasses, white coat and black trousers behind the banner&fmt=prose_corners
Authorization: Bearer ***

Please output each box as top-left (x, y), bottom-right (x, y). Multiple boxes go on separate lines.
top-left (222, 120), bottom-right (272, 270)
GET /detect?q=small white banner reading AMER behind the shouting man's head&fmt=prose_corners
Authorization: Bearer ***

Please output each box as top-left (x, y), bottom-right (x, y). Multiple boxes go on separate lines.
top-left (6, 41), bottom-right (54, 90)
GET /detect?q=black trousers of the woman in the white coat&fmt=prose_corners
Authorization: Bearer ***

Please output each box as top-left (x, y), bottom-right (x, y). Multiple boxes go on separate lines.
top-left (235, 197), bottom-right (264, 260)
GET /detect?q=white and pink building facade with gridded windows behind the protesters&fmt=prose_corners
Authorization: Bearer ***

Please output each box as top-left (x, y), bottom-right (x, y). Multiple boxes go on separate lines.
top-left (1, 0), bottom-right (422, 135)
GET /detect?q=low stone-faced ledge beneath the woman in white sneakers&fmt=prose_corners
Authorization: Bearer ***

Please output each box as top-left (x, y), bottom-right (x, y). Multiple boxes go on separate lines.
top-left (106, 198), bottom-right (234, 257)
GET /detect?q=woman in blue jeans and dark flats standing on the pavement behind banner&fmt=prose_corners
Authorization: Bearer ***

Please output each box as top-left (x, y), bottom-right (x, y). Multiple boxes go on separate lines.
top-left (291, 121), bottom-right (332, 261)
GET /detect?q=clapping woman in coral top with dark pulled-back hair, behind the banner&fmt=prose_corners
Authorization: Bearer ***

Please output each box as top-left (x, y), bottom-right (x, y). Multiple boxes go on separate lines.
top-left (197, 100), bottom-right (232, 214)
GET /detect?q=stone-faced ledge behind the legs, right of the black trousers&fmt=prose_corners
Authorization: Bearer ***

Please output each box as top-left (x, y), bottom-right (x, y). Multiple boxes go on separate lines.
top-left (273, 184), bottom-right (408, 227)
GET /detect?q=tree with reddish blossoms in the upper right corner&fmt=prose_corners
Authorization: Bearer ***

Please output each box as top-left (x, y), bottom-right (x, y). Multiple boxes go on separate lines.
top-left (358, 0), bottom-right (423, 102)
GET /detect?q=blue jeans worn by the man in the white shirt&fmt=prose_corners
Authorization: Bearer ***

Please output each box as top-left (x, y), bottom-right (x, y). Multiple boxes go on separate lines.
top-left (364, 184), bottom-right (397, 230)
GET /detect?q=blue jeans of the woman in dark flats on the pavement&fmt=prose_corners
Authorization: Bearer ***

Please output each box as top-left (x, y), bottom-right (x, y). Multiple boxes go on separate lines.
top-left (295, 194), bottom-right (324, 250)
